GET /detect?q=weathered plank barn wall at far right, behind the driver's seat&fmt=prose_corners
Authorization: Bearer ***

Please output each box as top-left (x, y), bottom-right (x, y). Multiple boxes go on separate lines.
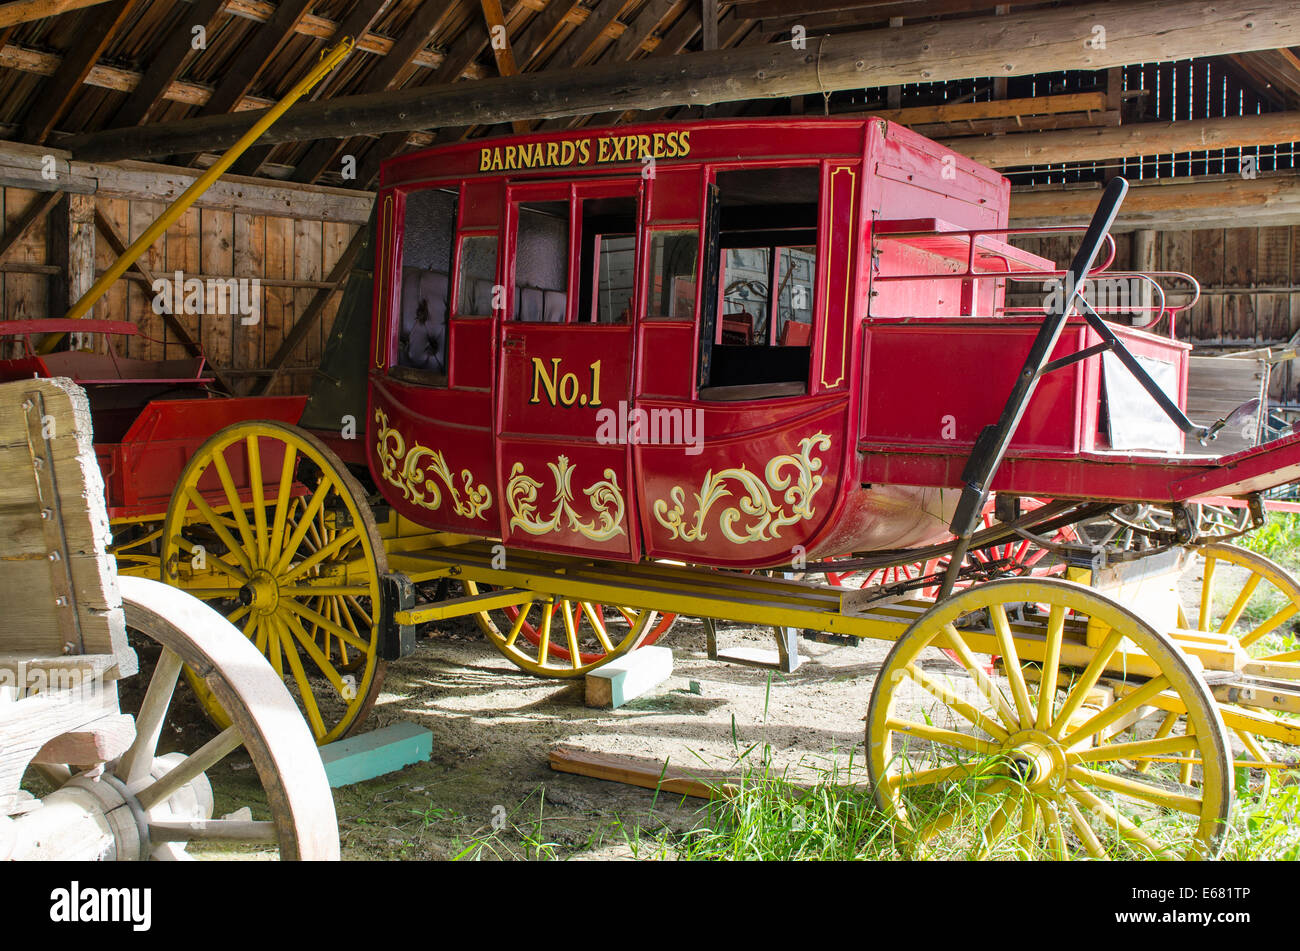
top-left (1015, 225), bottom-right (1300, 408)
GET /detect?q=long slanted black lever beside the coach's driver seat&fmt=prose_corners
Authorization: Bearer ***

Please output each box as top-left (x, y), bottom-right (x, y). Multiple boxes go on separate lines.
top-left (939, 177), bottom-right (1128, 600)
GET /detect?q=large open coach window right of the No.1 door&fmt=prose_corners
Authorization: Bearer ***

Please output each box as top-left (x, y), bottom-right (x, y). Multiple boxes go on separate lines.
top-left (699, 165), bottom-right (820, 400)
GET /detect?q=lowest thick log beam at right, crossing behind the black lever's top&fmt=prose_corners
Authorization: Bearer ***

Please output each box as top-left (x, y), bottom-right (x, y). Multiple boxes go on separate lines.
top-left (1011, 173), bottom-right (1300, 231)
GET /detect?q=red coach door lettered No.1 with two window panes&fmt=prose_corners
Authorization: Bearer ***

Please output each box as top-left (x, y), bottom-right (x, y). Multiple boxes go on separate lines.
top-left (497, 179), bottom-right (642, 559)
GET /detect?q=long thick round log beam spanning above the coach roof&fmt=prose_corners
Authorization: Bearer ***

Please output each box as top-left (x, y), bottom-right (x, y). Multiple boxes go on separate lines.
top-left (68, 0), bottom-right (1300, 161)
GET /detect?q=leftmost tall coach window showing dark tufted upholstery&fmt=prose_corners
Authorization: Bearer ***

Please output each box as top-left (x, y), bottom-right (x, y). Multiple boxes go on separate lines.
top-left (398, 188), bottom-right (456, 385)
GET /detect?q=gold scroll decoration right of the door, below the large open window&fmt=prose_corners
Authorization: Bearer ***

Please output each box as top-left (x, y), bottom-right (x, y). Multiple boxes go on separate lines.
top-left (654, 433), bottom-right (831, 544)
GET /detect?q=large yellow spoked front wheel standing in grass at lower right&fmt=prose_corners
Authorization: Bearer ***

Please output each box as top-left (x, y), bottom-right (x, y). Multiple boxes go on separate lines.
top-left (867, 578), bottom-right (1232, 857)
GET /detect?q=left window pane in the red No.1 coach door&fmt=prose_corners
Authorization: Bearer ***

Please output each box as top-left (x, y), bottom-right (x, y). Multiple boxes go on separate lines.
top-left (515, 201), bottom-right (569, 323)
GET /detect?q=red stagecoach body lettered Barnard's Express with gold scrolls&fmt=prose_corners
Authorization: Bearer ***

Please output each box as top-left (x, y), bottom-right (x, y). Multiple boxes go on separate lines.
top-left (367, 120), bottom-right (1187, 568)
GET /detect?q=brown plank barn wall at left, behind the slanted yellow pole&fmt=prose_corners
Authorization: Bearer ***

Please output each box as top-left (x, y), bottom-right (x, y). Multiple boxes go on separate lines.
top-left (0, 187), bottom-right (358, 394)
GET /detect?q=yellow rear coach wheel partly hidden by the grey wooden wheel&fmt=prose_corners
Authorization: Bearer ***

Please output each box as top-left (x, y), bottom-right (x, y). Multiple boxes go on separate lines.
top-left (161, 421), bottom-right (387, 743)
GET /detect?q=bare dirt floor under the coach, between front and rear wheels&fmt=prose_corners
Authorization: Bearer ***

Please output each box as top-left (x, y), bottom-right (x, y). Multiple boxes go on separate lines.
top-left (322, 620), bottom-right (888, 859)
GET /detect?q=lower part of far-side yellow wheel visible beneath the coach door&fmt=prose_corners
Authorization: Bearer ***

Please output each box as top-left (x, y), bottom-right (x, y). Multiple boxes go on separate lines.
top-left (465, 581), bottom-right (660, 677)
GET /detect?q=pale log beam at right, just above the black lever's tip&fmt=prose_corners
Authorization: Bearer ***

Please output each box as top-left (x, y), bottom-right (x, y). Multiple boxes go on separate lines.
top-left (944, 112), bottom-right (1300, 169)
